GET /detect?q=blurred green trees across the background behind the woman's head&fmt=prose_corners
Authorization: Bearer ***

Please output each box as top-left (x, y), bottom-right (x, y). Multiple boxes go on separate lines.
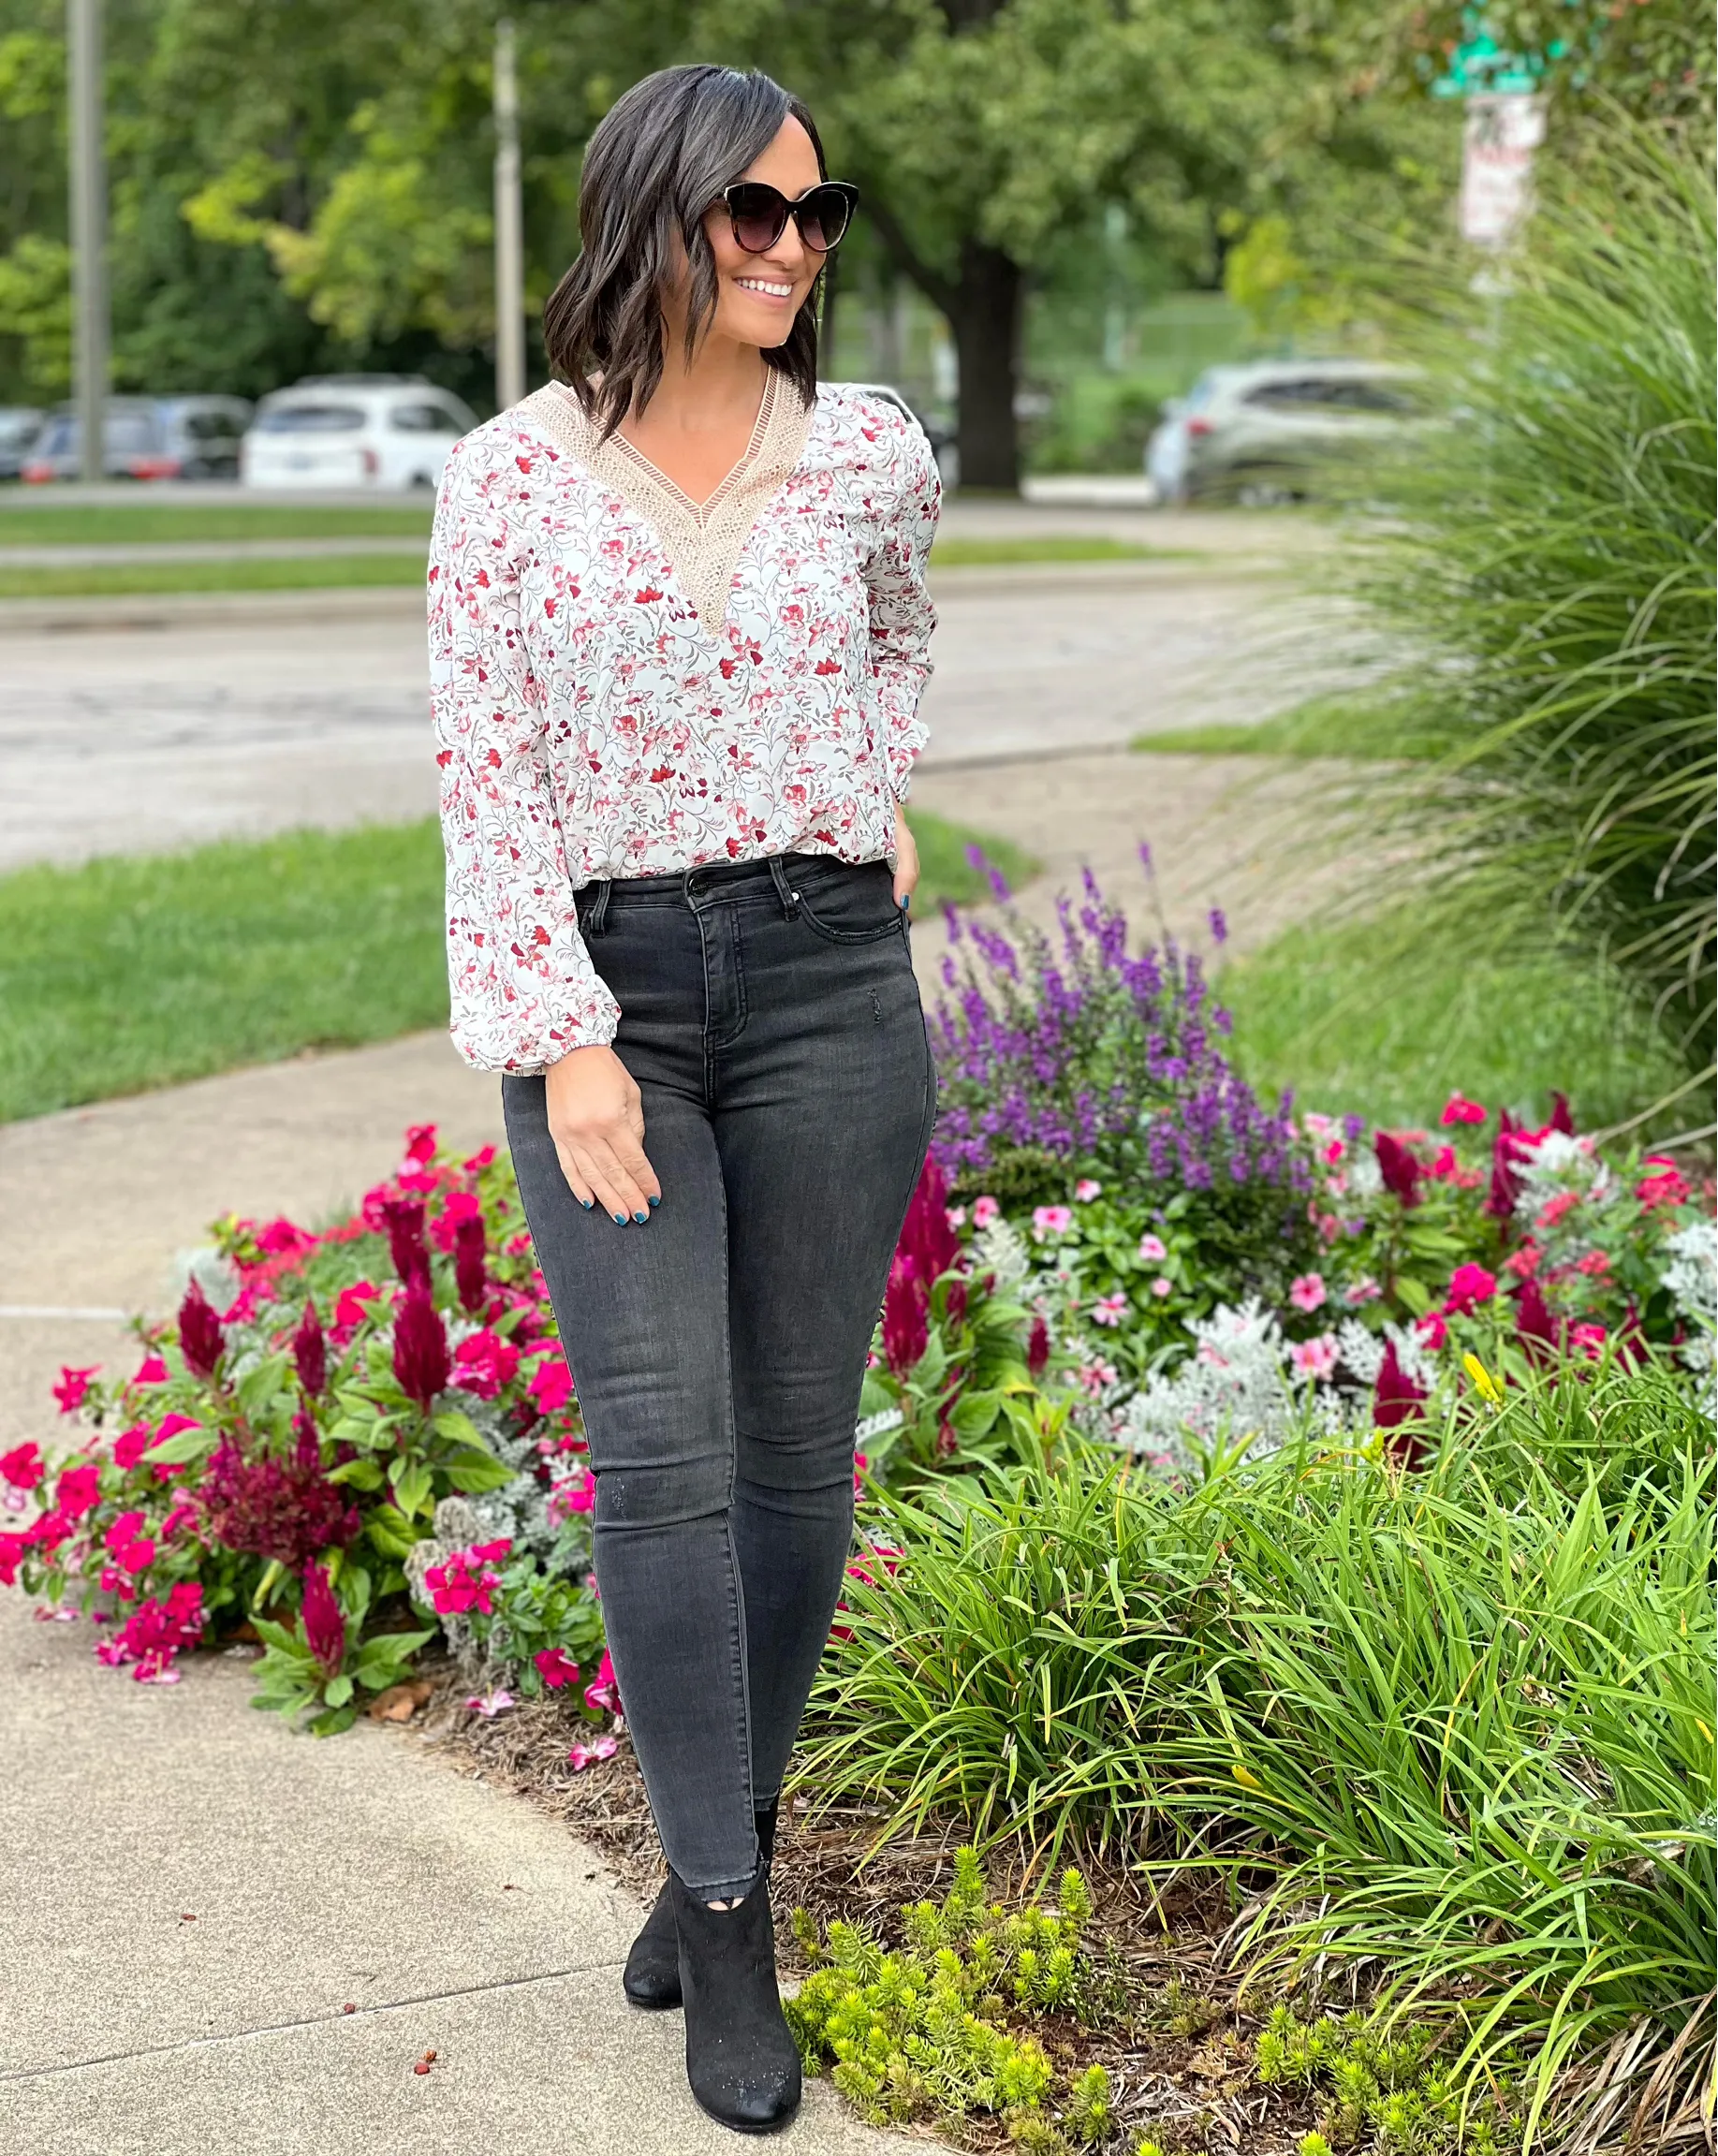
top-left (0, 0), bottom-right (1713, 485)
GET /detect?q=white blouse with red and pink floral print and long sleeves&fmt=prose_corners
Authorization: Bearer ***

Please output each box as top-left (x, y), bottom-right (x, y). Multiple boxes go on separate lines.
top-left (429, 373), bottom-right (940, 1074)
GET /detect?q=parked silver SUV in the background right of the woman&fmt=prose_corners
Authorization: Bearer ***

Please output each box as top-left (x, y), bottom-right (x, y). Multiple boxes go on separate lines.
top-left (1145, 360), bottom-right (1423, 505)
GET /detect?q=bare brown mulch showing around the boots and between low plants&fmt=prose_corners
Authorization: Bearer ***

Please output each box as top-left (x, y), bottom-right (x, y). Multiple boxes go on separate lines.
top-left (412, 1678), bottom-right (1317, 2156)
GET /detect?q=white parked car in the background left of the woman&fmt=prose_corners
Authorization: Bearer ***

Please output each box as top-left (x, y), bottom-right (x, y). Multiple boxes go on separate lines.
top-left (240, 375), bottom-right (477, 491)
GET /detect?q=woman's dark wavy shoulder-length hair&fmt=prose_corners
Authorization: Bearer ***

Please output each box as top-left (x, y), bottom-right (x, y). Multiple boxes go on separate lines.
top-left (543, 65), bottom-right (830, 440)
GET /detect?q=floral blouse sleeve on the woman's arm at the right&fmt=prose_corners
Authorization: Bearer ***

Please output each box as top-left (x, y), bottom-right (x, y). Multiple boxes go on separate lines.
top-left (864, 412), bottom-right (942, 802)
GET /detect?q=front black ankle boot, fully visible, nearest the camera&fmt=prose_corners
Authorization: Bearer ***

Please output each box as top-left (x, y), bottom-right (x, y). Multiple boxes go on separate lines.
top-left (668, 1871), bottom-right (800, 2134)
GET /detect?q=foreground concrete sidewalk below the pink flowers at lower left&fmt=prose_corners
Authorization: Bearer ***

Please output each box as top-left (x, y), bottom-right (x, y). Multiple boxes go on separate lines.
top-left (0, 1593), bottom-right (901, 2156)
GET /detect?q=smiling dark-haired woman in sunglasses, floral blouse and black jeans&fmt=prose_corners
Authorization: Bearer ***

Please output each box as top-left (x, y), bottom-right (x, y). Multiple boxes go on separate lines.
top-left (429, 66), bottom-right (938, 2133)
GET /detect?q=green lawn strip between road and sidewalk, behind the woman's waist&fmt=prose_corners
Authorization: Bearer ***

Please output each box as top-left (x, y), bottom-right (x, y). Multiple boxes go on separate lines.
top-left (0, 815), bottom-right (1033, 1122)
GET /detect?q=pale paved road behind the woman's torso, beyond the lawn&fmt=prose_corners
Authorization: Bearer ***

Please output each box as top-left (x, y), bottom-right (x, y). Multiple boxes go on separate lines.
top-left (0, 556), bottom-right (1330, 869)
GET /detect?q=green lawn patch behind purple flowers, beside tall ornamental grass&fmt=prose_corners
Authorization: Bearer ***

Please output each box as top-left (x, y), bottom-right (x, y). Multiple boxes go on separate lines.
top-left (1220, 912), bottom-right (1701, 1134)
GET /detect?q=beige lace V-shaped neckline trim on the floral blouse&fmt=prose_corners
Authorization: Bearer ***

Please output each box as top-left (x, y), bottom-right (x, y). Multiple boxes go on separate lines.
top-left (521, 369), bottom-right (813, 636)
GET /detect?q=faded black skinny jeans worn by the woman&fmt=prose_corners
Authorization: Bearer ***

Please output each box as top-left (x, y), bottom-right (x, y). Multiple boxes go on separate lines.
top-left (502, 854), bottom-right (935, 1899)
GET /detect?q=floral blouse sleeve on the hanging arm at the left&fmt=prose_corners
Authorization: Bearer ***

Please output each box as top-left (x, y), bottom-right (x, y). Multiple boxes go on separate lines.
top-left (429, 438), bottom-right (619, 1076)
